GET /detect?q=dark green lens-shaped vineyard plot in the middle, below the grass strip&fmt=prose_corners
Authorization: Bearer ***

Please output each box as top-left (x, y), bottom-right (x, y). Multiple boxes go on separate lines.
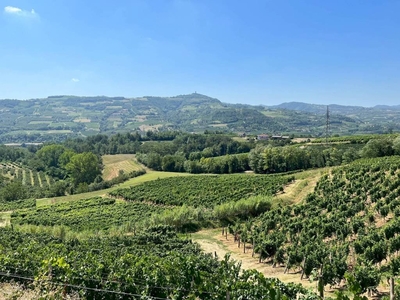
top-left (110, 174), bottom-right (294, 208)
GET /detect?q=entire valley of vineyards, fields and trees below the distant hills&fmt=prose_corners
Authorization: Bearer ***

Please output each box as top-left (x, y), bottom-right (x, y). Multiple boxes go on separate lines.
top-left (0, 128), bottom-right (400, 299)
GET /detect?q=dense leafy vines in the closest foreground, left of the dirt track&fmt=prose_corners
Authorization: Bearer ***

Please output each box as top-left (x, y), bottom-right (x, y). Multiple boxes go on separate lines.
top-left (0, 227), bottom-right (316, 299)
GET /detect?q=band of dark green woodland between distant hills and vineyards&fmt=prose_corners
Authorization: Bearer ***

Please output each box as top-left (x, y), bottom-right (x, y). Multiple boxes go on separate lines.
top-left (0, 131), bottom-right (400, 200)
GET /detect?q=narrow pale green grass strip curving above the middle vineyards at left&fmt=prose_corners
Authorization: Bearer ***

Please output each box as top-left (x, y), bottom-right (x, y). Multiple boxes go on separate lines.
top-left (36, 171), bottom-right (193, 207)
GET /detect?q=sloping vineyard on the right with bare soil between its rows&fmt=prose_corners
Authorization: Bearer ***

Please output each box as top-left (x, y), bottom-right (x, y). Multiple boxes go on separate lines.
top-left (227, 157), bottom-right (400, 292)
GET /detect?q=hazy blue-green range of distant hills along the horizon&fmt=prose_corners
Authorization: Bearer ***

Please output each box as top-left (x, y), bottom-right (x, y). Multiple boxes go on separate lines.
top-left (0, 93), bottom-right (400, 143)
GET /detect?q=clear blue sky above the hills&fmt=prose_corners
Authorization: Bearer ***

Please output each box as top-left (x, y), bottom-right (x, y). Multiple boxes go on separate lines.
top-left (0, 0), bottom-right (400, 106)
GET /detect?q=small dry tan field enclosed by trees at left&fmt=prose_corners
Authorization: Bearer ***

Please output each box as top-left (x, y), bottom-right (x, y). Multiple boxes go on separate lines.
top-left (102, 154), bottom-right (144, 180)
